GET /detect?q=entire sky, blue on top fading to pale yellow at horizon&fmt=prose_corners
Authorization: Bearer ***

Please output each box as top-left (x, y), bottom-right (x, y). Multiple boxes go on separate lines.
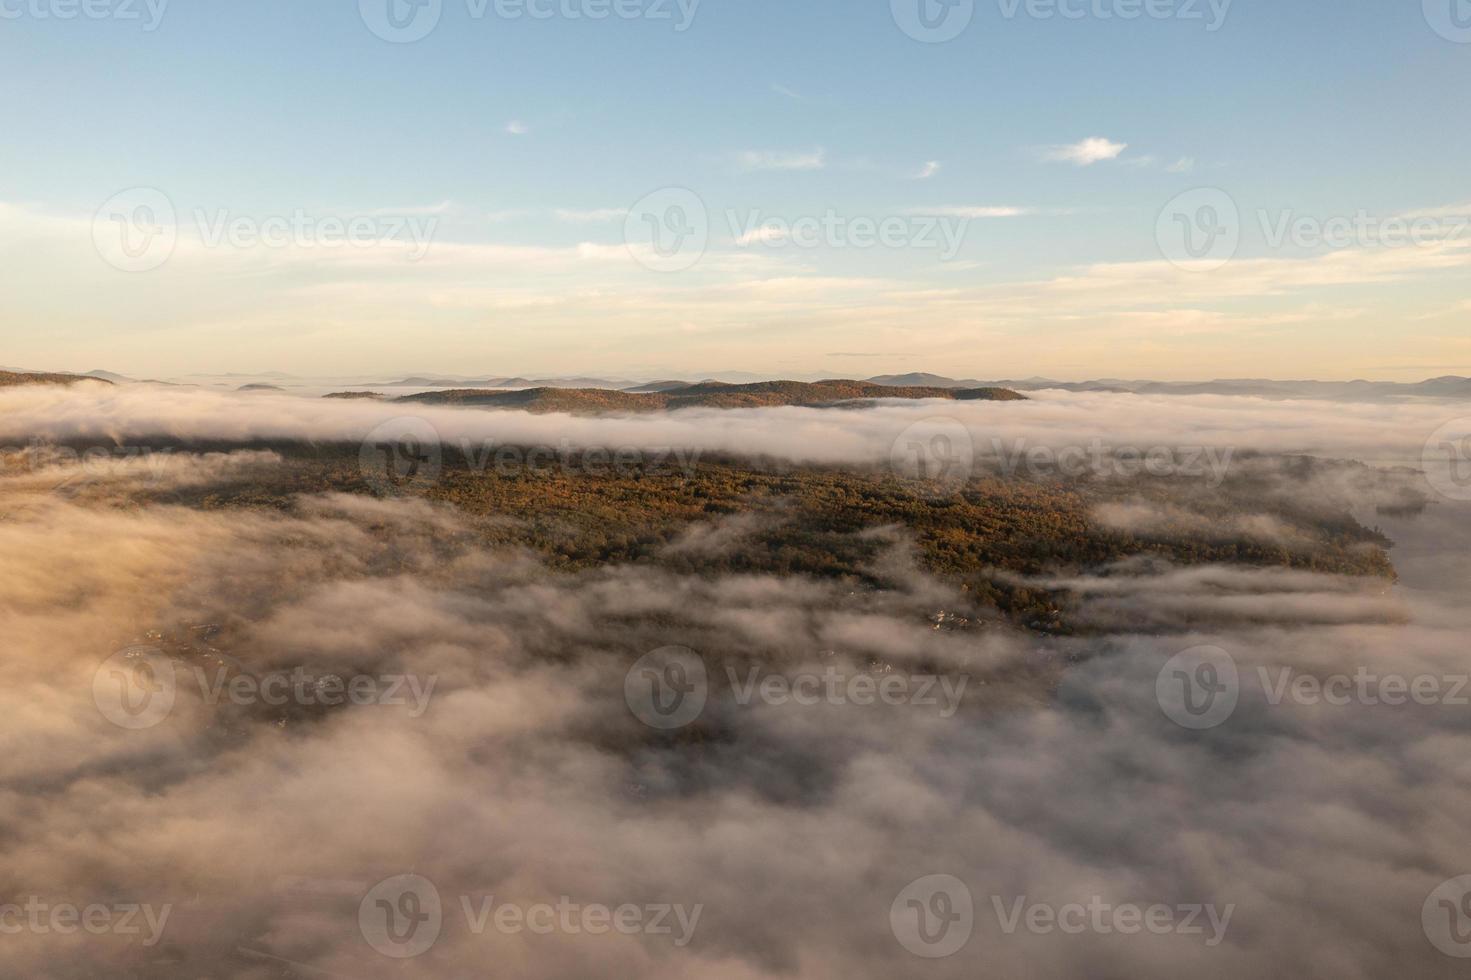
top-left (0, 0), bottom-right (1471, 378)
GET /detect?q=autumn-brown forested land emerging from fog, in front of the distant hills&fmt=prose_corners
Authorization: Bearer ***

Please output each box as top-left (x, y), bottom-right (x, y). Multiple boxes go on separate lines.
top-left (108, 446), bottom-right (1393, 630)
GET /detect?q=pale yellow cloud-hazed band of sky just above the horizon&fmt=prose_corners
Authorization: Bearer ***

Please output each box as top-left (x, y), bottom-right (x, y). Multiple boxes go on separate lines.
top-left (0, 198), bottom-right (1471, 381)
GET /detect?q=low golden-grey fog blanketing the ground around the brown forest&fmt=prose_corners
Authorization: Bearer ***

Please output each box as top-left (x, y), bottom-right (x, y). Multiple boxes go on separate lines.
top-left (0, 386), bottom-right (1471, 980)
